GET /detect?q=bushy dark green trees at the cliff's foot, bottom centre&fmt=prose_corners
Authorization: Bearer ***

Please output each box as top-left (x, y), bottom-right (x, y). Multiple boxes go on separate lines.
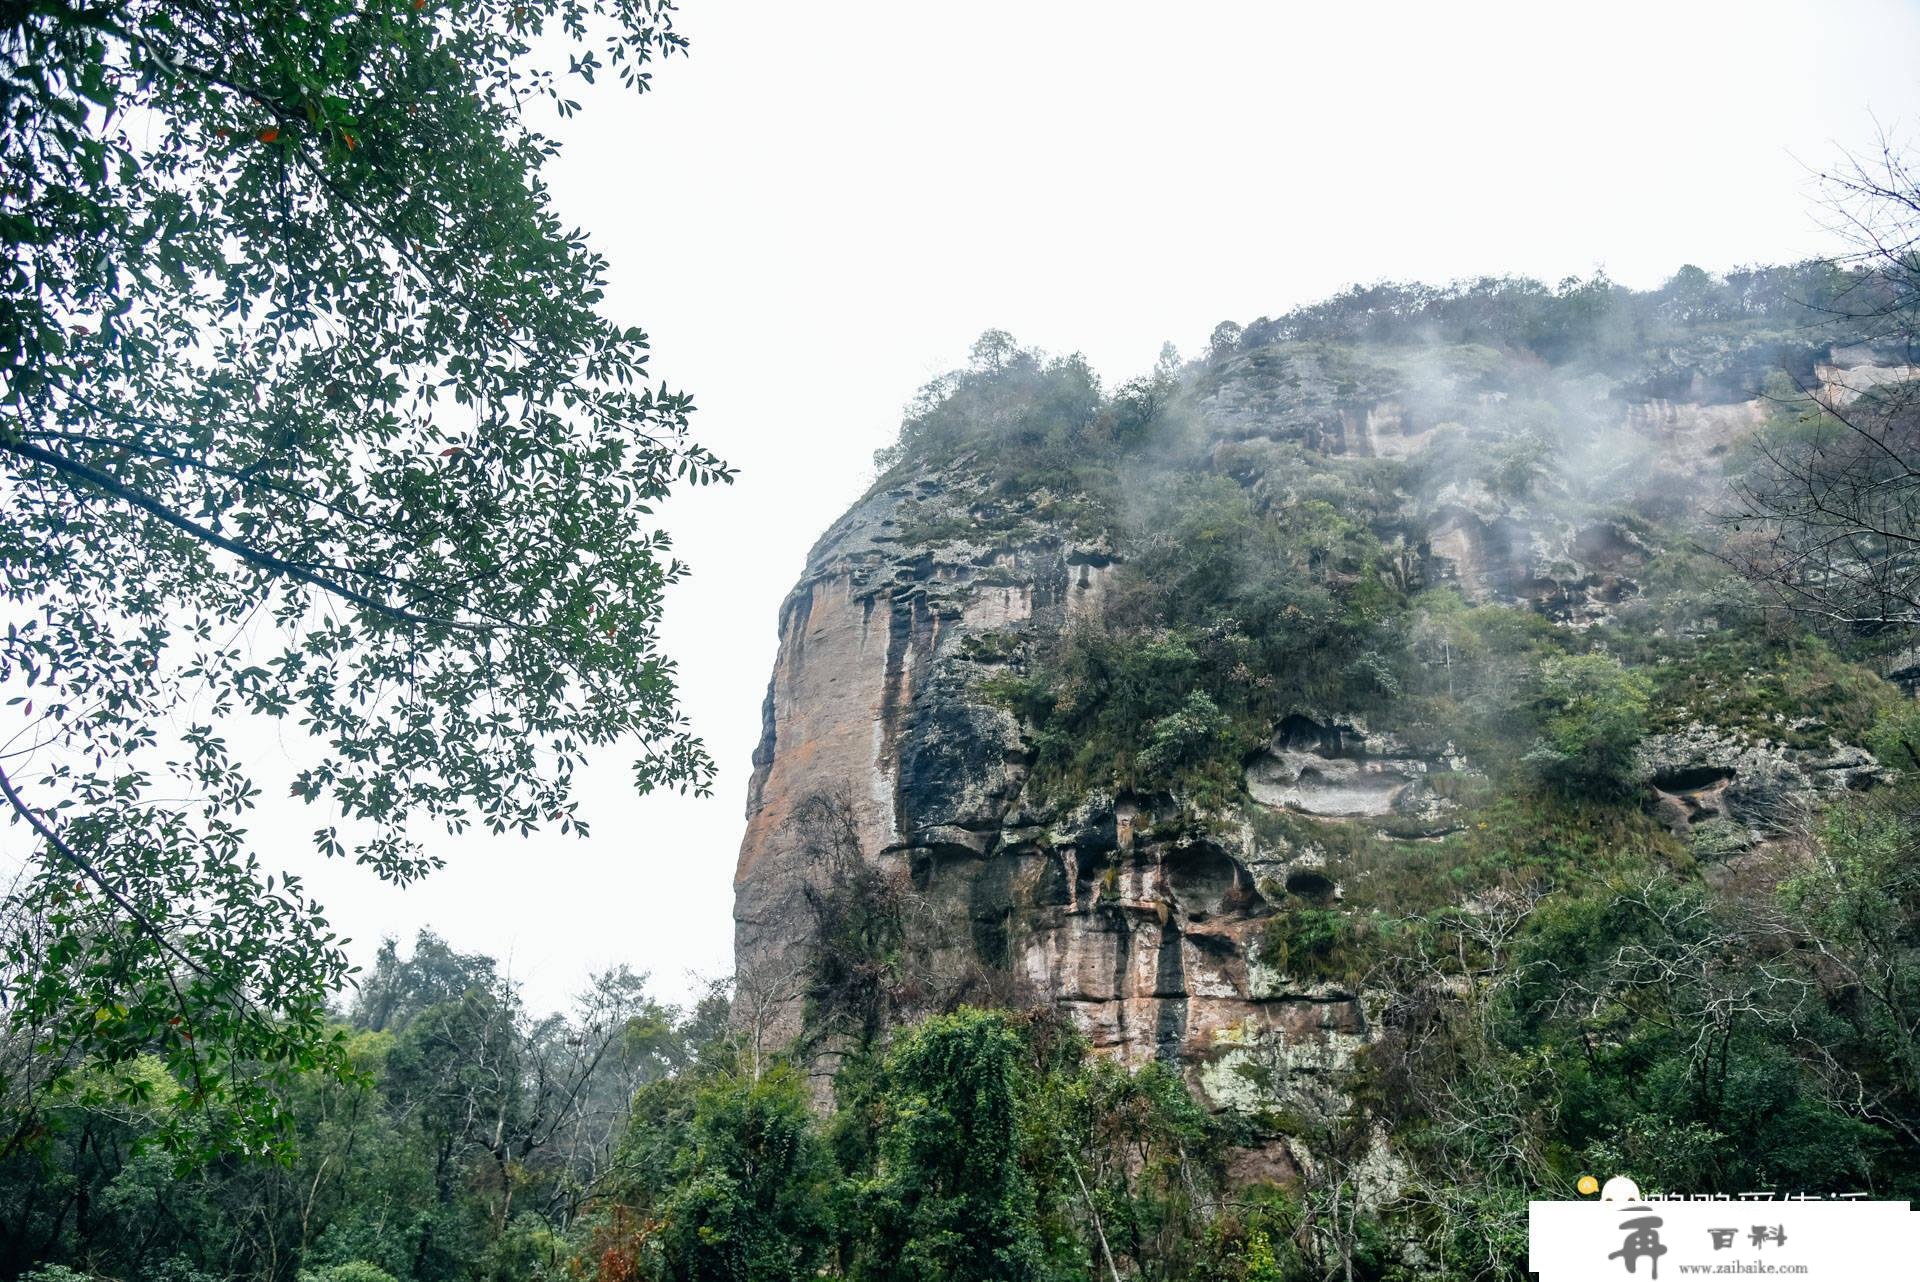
top-left (556, 1008), bottom-right (1292, 1282)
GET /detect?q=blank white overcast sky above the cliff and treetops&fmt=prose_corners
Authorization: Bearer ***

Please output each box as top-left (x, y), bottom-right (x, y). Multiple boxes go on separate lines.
top-left (261, 0), bottom-right (1920, 1006)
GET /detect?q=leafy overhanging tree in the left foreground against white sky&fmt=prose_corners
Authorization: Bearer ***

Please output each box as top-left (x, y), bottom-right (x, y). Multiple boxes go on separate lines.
top-left (0, 0), bottom-right (730, 1151)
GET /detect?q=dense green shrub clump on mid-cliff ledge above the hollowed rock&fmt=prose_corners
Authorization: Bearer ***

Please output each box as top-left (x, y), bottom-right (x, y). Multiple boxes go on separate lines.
top-left (995, 466), bottom-right (1404, 808)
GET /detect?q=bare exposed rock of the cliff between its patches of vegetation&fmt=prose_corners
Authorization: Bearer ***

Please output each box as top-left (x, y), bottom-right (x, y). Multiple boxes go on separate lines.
top-left (735, 335), bottom-right (1904, 1113)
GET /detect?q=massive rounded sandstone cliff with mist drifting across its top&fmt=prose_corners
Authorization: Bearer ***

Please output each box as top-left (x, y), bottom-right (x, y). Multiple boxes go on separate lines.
top-left (735, 270), bottom-right (1912, 1173)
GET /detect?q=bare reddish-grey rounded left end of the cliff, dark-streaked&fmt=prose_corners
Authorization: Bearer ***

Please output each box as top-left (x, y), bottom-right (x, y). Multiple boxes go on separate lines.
top-left (733, 460), bottom-right (1131, 1040)
